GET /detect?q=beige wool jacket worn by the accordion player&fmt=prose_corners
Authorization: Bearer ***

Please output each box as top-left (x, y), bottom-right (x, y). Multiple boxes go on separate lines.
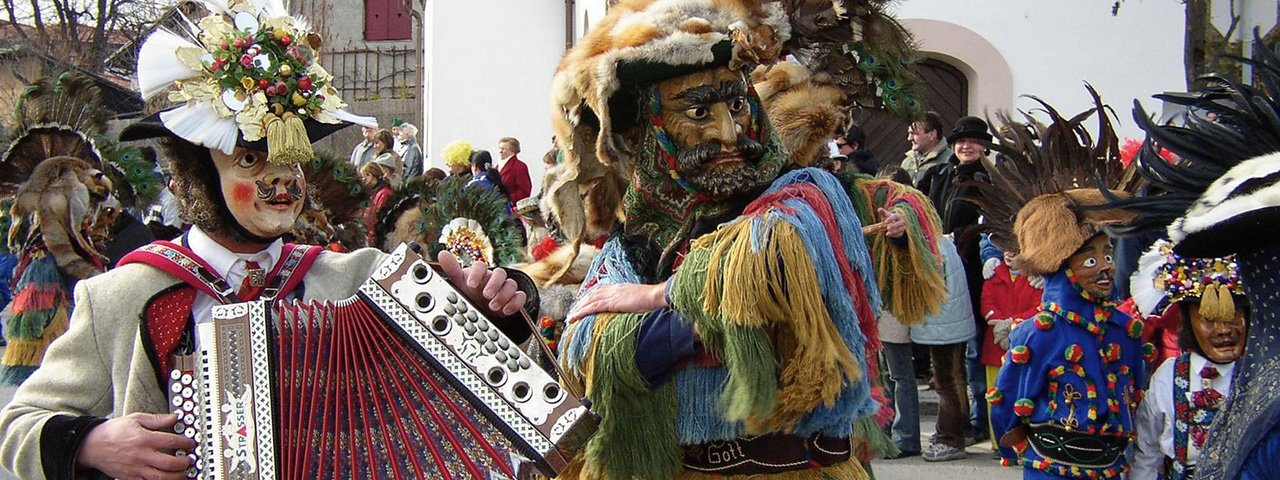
top-left (0, 248), bottom-right (385, 479)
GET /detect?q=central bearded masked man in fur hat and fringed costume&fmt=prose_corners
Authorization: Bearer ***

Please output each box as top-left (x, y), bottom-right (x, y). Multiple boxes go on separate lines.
top-left (548, 0), bottom-right (943, 479)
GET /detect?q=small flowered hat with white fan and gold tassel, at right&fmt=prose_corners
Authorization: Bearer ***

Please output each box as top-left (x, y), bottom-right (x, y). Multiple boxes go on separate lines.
top-left (1133, 241), bottom-right (1244, 321)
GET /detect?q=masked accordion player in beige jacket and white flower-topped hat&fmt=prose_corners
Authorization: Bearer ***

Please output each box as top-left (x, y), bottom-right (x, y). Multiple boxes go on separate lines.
top-left (0, 1), bottom-right (526, 479)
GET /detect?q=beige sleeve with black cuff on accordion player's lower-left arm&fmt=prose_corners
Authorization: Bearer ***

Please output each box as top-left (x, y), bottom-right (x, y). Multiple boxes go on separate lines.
top-left (0, 282), bottom-right (113, 479)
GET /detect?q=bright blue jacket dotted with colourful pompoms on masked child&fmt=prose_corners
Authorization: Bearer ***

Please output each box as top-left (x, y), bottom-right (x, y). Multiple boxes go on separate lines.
top-left (987, 269), bottom-right (1153, 479)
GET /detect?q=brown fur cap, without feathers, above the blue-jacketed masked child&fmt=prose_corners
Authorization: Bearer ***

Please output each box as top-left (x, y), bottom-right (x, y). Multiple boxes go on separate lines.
top-left (1014, 188), bottom-right (1134, 275)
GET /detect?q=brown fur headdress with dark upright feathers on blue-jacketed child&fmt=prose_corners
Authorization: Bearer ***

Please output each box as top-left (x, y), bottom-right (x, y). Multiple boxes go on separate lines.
top-left (969, 86), bottom-right (1134, 275)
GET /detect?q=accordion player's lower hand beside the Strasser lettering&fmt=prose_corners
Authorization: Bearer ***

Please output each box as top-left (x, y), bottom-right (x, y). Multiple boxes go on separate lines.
top-left (76, 413), bottom-right (196, 480)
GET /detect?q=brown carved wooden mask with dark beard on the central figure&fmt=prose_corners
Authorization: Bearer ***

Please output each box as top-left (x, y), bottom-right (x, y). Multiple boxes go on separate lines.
top-left (658, 68), bottom-right (764, 200)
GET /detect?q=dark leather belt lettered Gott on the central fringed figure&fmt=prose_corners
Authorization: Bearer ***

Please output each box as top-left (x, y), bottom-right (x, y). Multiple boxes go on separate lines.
top-left (684, 434), bottom-right (851, 475)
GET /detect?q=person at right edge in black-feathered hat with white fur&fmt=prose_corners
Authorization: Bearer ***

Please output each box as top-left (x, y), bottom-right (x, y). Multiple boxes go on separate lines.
top-left (1095, 37), bottom-right (1280, 480)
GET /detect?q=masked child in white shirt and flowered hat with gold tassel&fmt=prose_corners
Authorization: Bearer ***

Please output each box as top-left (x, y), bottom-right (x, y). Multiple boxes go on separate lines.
top-left (1130, 241), bottom-right (1249, 480)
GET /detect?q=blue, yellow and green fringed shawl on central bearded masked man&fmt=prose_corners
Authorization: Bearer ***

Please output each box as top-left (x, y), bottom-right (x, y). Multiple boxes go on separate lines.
top-left (561, 169), bottom-right (879, 479)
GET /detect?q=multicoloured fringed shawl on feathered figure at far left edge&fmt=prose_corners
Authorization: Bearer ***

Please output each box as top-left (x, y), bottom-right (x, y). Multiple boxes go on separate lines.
top-left (0, 248), bottom-right (70, 385)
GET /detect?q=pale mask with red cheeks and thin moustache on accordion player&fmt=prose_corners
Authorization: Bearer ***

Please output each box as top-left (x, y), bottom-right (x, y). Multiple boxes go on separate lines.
top-left (211, 147), bottom-right (306, 239)
